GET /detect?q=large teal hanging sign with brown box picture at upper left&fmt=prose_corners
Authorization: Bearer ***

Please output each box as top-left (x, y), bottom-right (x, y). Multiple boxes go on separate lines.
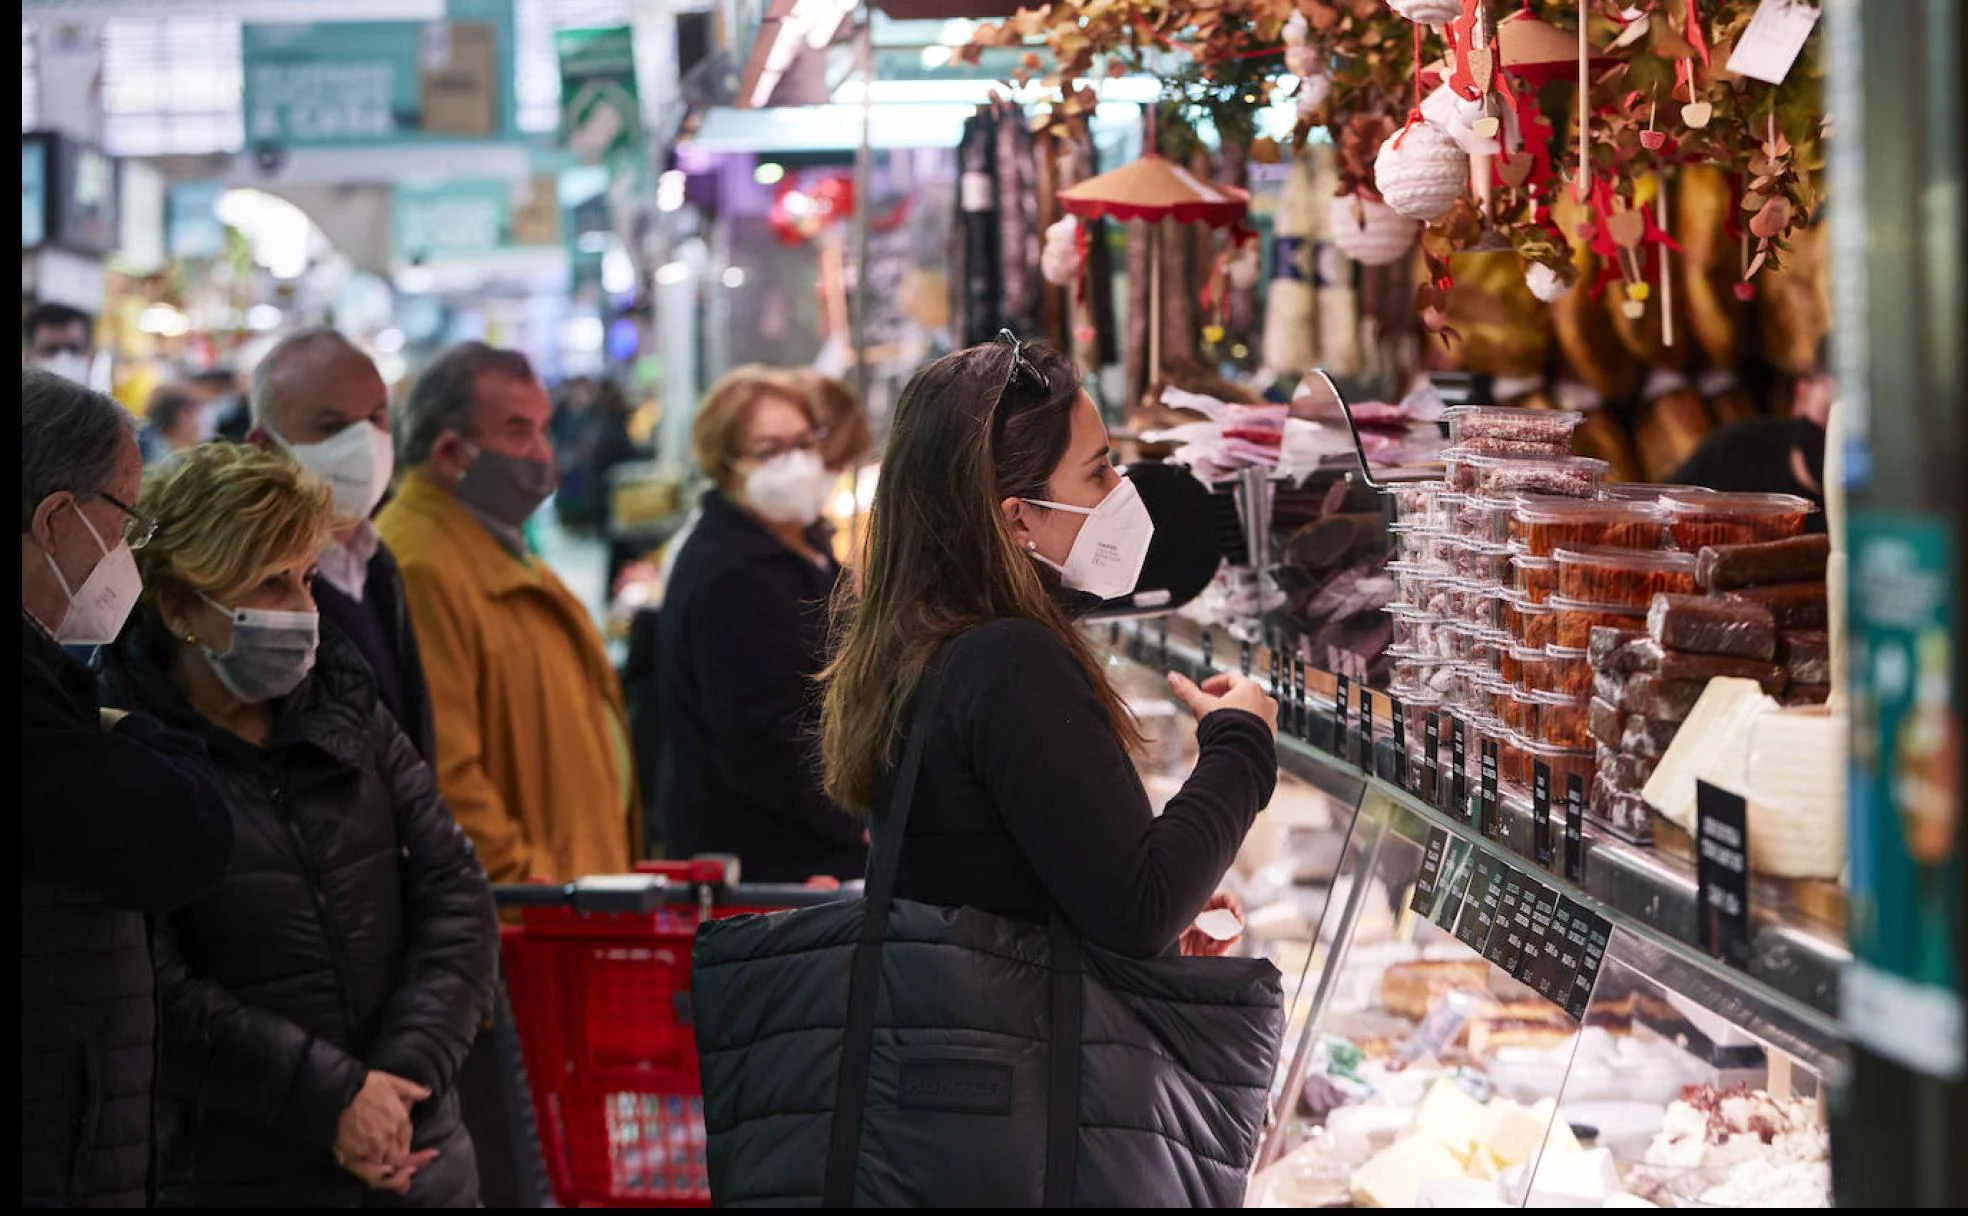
top-left (240, 0), bottom-right (518, 148)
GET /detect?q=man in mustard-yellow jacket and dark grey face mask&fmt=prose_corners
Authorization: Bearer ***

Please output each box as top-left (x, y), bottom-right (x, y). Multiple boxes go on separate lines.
top-left (376, 342), bottom-right (636, 882)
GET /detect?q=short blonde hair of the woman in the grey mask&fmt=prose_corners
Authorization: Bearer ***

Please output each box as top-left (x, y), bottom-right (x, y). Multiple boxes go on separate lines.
top-left (136, 443), bottom-right (335, 604)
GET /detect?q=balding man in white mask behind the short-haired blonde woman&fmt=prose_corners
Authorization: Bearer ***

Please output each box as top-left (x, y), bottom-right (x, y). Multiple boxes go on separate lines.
top-left (246, 329), bottom-right (437, 763)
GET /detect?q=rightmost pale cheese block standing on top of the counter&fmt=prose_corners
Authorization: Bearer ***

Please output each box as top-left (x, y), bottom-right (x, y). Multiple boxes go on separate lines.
top-left (1746, 710), bottom-right (1848, 878)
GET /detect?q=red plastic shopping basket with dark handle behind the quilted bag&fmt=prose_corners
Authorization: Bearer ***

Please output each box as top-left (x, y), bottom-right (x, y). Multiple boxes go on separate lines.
top-left (496, 860), bottom-right (838, 1208)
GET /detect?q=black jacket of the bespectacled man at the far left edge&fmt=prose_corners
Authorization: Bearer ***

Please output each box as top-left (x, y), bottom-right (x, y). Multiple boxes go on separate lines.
top-left (20, 614), bottom-right (232, 1208)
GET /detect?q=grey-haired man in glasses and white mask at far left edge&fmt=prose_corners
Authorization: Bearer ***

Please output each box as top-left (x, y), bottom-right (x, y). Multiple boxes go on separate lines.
top-left (20, 370), bottom-right (232, 1206)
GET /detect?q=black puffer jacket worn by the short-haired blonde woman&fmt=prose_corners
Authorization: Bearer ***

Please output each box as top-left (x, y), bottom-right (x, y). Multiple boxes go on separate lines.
top-left (102, 614), bottom-right (498, 1206)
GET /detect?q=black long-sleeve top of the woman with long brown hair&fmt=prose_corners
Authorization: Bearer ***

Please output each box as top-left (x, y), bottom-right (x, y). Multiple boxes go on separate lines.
top-left (876, 620), bottom-right (1277, 958)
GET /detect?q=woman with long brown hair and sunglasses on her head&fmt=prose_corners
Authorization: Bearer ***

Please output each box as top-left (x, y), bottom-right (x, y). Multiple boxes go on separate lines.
top-left (821, 334), bottom-right (1277, 958)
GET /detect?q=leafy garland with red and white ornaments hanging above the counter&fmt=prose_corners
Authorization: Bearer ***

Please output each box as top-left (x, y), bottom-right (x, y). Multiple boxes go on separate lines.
top-left (966, 0), bottom-right (1824, 329)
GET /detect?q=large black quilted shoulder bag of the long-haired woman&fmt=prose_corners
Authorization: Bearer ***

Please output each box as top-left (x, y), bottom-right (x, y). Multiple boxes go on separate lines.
top-left (691, 661), bottom-right (1283, 1206)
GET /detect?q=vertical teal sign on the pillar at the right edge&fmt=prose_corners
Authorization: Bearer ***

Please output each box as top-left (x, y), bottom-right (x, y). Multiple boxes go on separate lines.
top-left (1838, 512), bottom-right (1968, 1078)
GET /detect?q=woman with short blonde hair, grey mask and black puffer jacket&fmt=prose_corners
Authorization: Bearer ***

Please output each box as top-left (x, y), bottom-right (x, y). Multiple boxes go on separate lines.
top-left (102, 445), bottom-right (498, 1206)
